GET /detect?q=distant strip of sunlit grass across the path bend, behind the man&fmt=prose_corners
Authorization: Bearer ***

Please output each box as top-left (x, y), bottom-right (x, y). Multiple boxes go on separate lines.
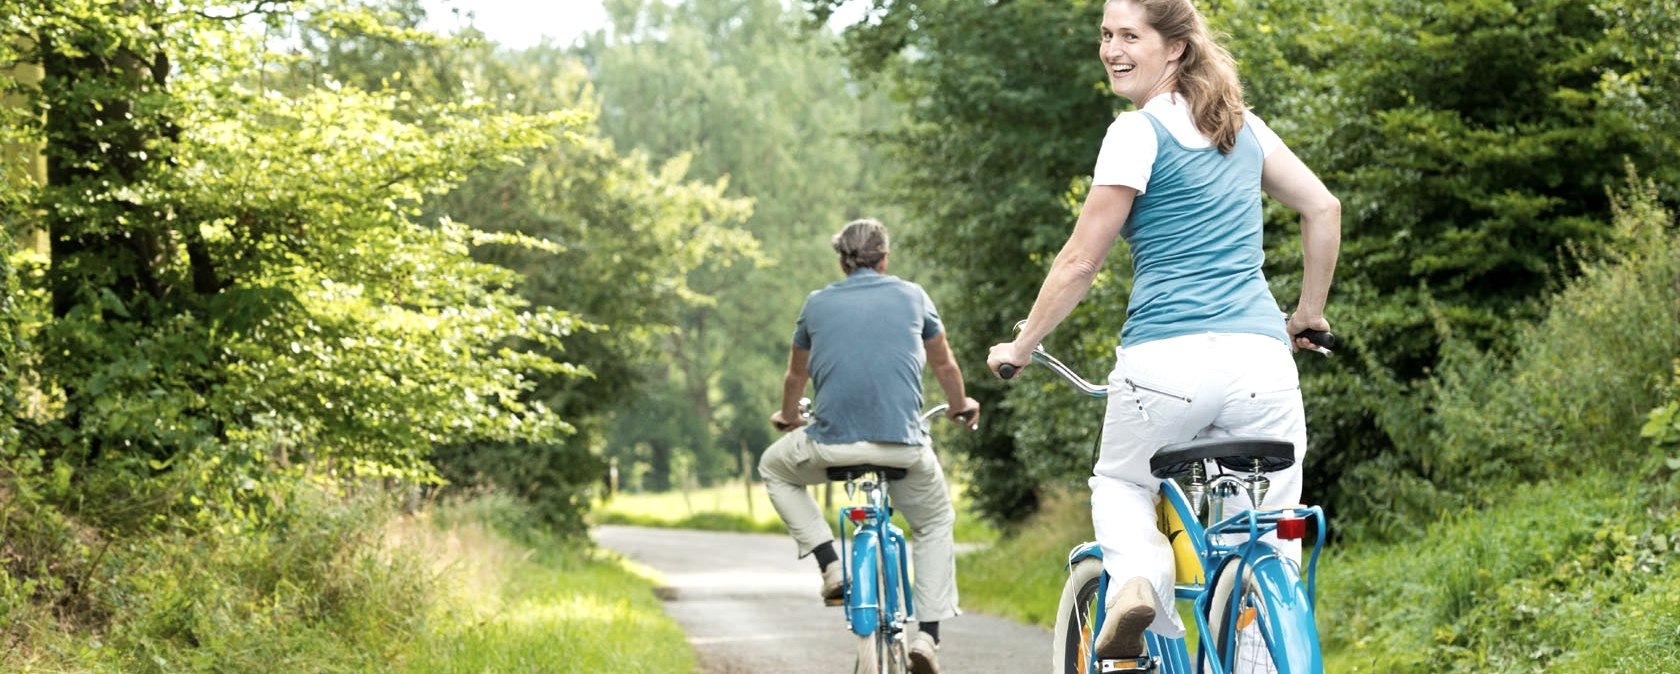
top-left (590, 482), bottom-right (998, 545)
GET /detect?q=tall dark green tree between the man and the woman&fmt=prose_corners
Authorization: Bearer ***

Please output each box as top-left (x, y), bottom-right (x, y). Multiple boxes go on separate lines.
top-left (808, 0), bottom-right (1122, 519)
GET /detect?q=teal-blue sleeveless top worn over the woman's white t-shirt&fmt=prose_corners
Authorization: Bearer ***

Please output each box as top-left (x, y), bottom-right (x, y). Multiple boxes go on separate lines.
top-left (1121, 113), bottom-right (1289, 346)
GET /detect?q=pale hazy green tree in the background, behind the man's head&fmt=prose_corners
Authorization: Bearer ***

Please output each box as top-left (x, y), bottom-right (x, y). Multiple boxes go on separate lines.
top-left (580, 0), bottom-right (914, 487)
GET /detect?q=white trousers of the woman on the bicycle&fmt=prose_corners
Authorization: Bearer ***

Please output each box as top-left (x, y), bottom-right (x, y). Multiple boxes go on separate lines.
top-left (1090, 333), bottom-right (1307, 637)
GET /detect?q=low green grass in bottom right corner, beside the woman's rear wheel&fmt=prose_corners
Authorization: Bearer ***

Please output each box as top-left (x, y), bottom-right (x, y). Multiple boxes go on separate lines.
top-left (1319, 474), bottom-right (1680, 674)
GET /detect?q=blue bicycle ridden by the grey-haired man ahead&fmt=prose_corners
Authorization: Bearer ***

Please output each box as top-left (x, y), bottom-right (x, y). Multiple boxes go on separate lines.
top-left (816, 400), bottom-right (974, 674)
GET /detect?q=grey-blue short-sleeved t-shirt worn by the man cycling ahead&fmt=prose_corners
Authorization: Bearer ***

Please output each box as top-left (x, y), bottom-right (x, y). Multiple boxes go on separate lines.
top-left (793, 269), bottom-right (944, 445)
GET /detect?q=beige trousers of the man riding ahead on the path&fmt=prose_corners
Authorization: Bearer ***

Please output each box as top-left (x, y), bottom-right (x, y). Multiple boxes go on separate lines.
top-left (758, 429), bottom-right (963, 622)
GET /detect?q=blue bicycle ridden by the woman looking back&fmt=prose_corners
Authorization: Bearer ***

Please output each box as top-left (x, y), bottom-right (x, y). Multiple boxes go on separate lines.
top-left (1000, 331), bottom-right (1334, 674)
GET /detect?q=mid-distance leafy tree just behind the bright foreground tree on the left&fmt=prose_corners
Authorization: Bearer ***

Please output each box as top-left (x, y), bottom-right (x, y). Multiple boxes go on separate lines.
top-left (235, 0), bottom-right (756, 528)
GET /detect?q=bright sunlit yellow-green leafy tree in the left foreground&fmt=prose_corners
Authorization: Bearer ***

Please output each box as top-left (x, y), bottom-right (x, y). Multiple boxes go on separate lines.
top-left (0, 2), bottom-right (585, 526)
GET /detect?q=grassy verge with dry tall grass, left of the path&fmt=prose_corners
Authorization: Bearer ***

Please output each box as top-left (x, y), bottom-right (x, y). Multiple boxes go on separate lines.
top-left (0, 492), bottom-right (694, 674)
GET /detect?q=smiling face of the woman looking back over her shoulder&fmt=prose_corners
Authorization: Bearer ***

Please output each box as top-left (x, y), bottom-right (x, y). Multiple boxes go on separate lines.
top-left (1102, 0), bottom-right (1184, 106)
